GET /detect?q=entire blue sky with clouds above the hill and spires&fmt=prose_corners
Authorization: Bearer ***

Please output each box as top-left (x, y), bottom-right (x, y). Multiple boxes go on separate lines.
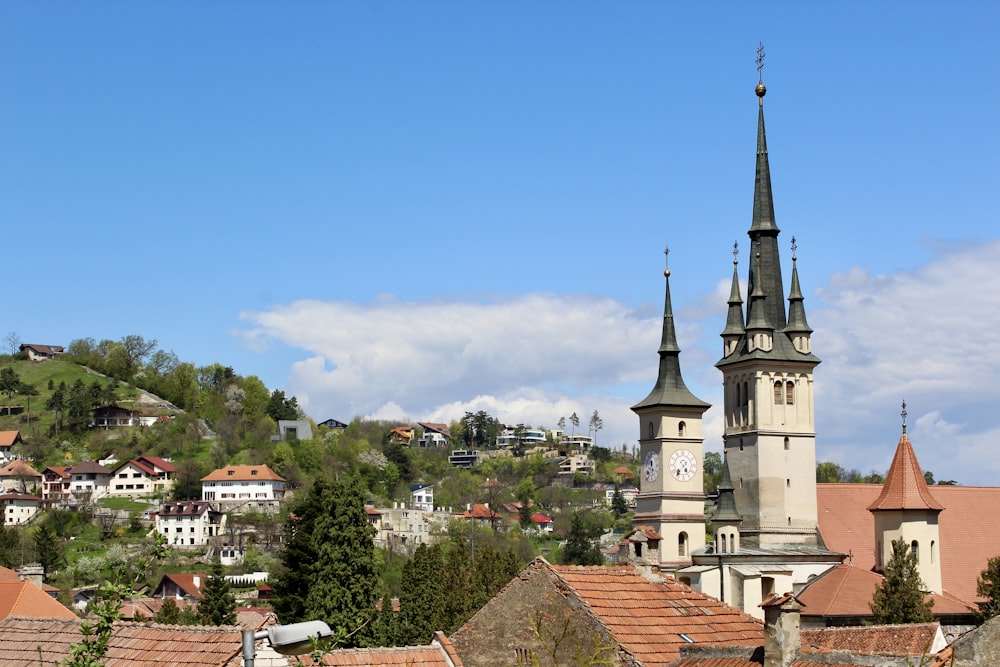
top-left (0, 2), bottom-right (1000, 484)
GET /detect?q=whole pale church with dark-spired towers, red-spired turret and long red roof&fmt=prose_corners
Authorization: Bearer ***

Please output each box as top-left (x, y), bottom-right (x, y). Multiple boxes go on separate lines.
top-left (622, 74), bottom-right (1000, 623)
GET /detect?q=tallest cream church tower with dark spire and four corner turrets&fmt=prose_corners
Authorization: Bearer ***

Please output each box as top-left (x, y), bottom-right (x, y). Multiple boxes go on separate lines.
top-left (716, 78), bottom-right (820, 547)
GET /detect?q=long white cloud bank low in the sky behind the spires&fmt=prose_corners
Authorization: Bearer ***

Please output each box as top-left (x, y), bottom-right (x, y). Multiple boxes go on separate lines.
top-left (243, 241), bottom-right (1000, 484)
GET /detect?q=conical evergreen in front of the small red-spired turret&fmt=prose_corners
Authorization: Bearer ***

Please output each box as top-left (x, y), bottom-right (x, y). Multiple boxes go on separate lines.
top-left (869, 539), bottom-right (934, 625)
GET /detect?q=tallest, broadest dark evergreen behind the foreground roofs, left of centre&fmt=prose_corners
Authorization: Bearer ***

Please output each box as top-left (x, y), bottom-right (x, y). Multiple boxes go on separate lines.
top-left (274, 478), bottom-right (379, 646)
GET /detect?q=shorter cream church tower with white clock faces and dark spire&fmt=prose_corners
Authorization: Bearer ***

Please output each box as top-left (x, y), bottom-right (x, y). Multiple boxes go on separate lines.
top-left (632, 251), bottom-right (711, 571)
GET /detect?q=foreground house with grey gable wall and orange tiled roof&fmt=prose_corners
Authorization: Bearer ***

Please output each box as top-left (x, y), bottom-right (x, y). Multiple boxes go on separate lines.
top-left (451, 558), bottom-right (764, 667)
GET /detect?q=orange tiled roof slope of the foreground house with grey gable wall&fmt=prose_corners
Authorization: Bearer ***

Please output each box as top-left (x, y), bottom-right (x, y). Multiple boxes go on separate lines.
top-left (543, 561), bottom-right (764, 665)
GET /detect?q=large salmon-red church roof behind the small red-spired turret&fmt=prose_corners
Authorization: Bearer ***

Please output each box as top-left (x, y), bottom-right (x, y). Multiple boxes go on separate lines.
top-left (816, 484), bottom-right (1000, 602)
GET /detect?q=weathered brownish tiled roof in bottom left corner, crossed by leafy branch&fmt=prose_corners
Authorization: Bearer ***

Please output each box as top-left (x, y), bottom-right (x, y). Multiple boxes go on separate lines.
top-left (0, 617), bottom-right (242, 667)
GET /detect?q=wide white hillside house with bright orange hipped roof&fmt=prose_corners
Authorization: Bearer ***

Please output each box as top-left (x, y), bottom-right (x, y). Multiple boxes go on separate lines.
top-left (201, 465), bottom-right (285, 514)
